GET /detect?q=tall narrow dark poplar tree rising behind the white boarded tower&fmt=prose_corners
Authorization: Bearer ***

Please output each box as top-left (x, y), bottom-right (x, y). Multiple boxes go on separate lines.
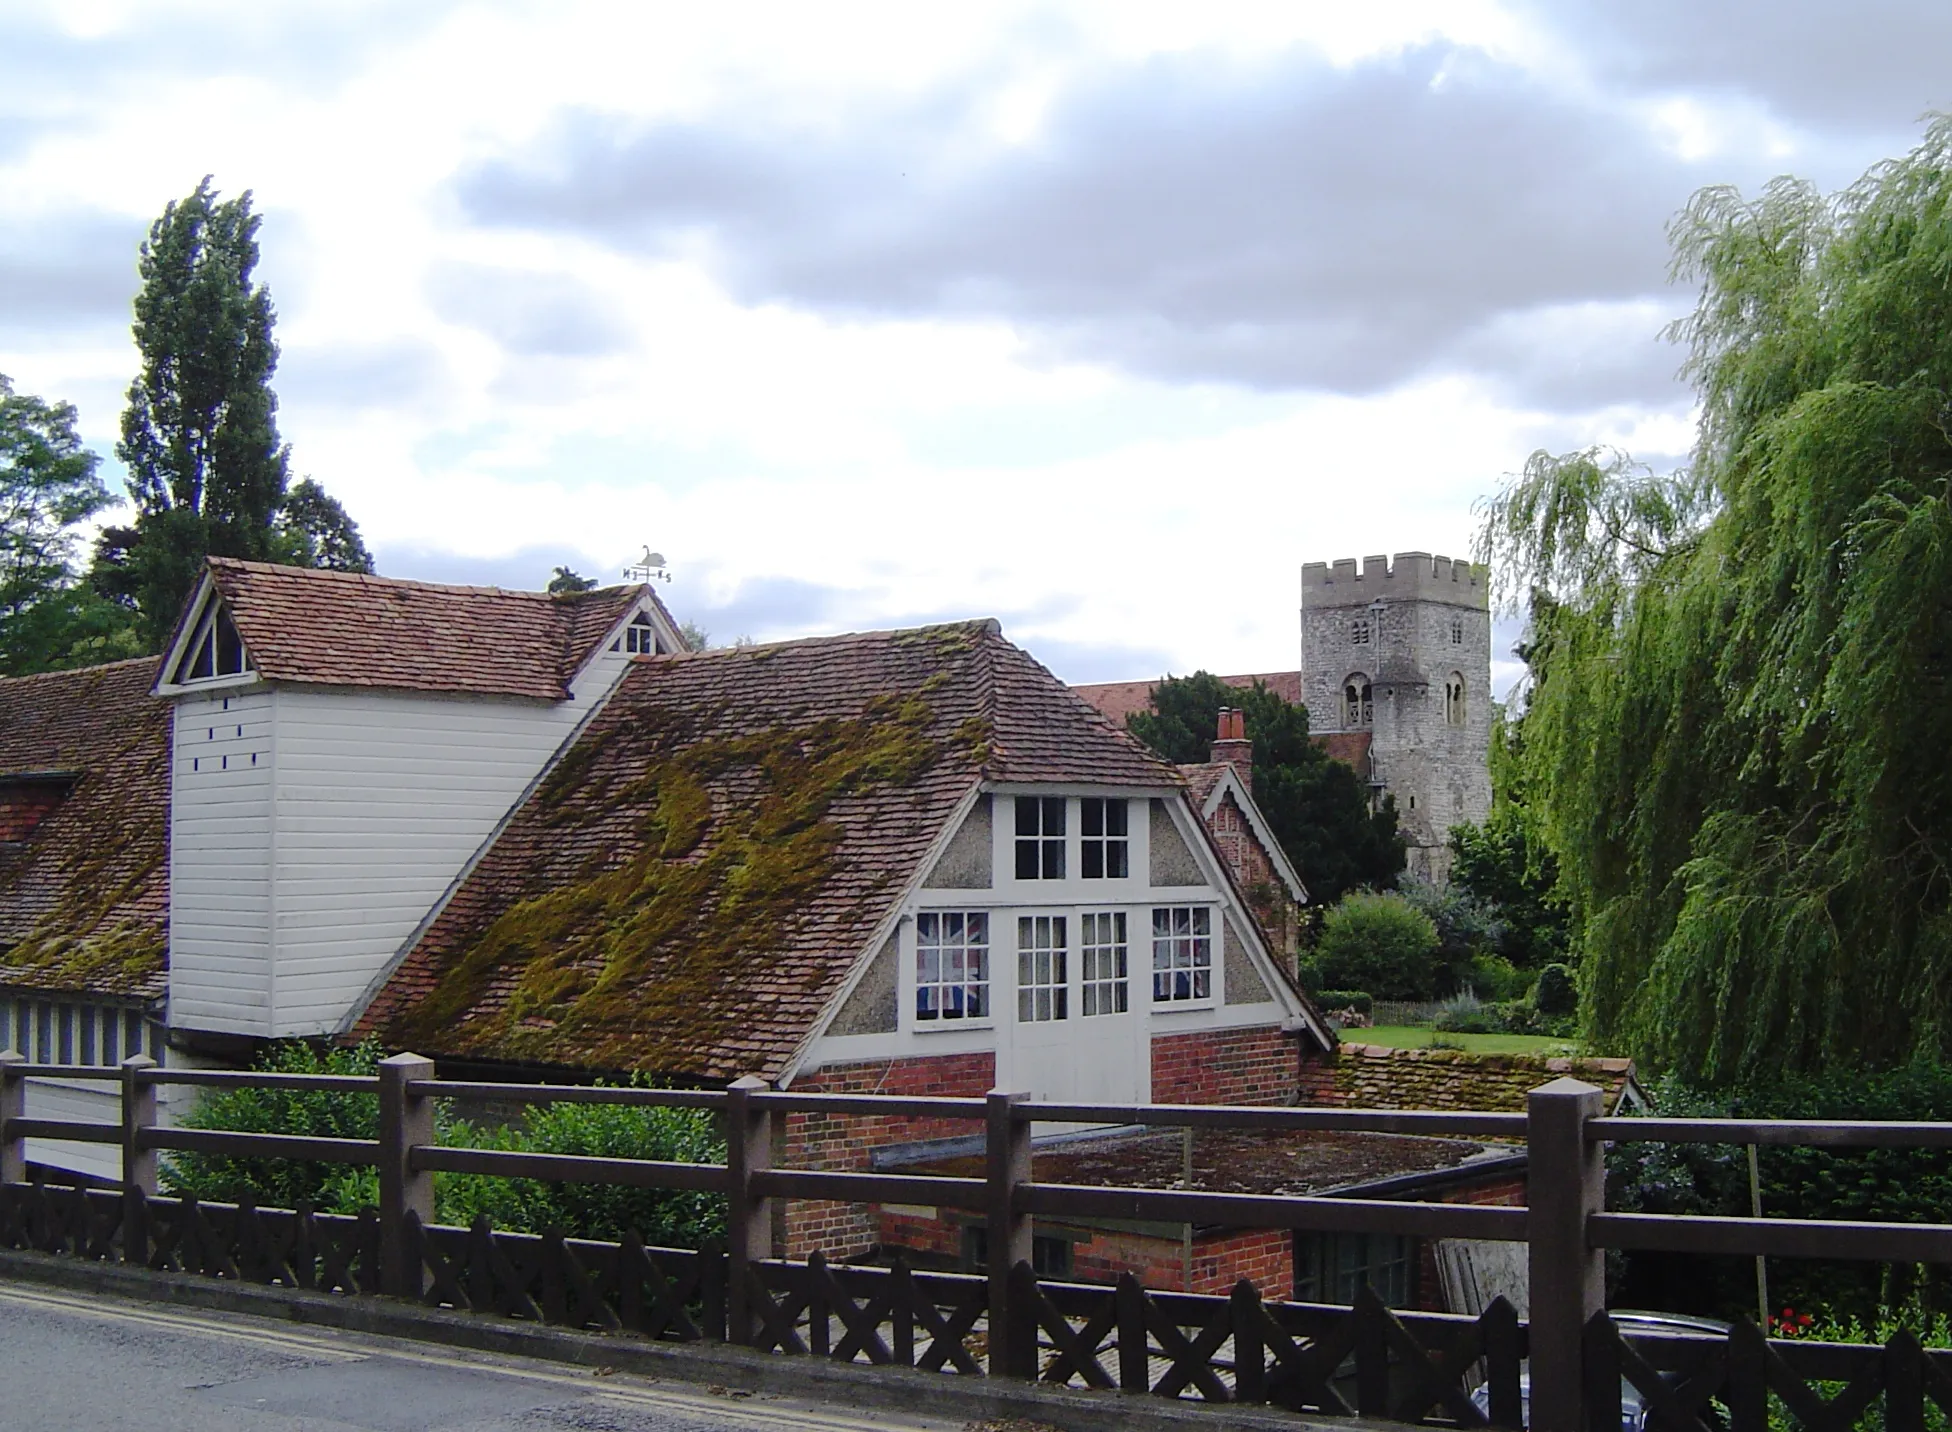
top-left (92, 176), bottom-right (373, 648)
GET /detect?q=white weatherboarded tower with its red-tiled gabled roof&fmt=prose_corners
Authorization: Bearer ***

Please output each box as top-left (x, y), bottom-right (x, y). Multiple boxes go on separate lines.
top-left (156, 562), bottom-right (685, 1038)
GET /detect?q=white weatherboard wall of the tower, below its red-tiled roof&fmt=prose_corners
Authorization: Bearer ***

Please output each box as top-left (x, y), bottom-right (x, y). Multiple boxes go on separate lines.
top-left (170, 650), bottom-right (629, 1038)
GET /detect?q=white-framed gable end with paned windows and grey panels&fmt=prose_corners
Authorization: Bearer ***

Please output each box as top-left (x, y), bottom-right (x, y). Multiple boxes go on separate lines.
top-left (800, 786), bottom-right (1331, 1104)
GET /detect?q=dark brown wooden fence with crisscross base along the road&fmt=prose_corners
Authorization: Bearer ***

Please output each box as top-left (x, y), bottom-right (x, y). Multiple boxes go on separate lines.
top-left (0, 1054), bottom-right (1952, 1432)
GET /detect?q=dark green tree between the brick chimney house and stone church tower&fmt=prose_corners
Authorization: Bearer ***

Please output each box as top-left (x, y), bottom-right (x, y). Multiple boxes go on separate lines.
top-left (1126, 671), bottom-right (1403, 905)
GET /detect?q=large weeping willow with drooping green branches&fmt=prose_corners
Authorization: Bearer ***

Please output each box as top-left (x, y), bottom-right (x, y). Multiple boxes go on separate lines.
top-left (1480, 117), bottom-right (1952, 1085)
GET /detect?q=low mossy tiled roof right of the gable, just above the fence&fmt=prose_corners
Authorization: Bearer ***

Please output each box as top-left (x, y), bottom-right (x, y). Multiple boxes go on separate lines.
top-left (1302, 1030), bottom-right (1642, 1114)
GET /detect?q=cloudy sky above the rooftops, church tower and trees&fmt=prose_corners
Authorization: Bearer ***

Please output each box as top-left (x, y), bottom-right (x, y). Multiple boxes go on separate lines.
top-left (0, 0), bottom-right (1952, 687)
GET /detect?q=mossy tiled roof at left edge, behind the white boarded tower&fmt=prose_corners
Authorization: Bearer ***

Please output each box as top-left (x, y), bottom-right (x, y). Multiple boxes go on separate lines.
top-left (0, 657), bottom-right (170, 999)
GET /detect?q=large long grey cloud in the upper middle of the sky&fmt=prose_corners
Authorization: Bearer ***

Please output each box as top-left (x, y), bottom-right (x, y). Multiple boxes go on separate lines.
top-left (457, 45), bottom-right (1700, 403)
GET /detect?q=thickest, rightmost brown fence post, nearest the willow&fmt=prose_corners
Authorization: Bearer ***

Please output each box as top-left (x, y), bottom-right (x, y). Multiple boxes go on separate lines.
top-left (1525, 1079), bottom-right (1606, 1432)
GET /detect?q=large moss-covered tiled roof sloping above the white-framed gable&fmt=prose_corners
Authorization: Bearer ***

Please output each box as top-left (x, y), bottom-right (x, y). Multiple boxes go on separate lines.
top-left (355, 622), bottom-right (1179, 1079)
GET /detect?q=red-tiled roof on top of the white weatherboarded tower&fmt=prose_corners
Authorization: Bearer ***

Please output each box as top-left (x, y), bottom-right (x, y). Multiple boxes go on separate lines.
top-left (185, 558), bottom-right (656, 700)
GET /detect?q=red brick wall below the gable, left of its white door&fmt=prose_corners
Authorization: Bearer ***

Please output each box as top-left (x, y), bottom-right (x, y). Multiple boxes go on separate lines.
top-left (775, 1052), bottom-right (996, 1258)
